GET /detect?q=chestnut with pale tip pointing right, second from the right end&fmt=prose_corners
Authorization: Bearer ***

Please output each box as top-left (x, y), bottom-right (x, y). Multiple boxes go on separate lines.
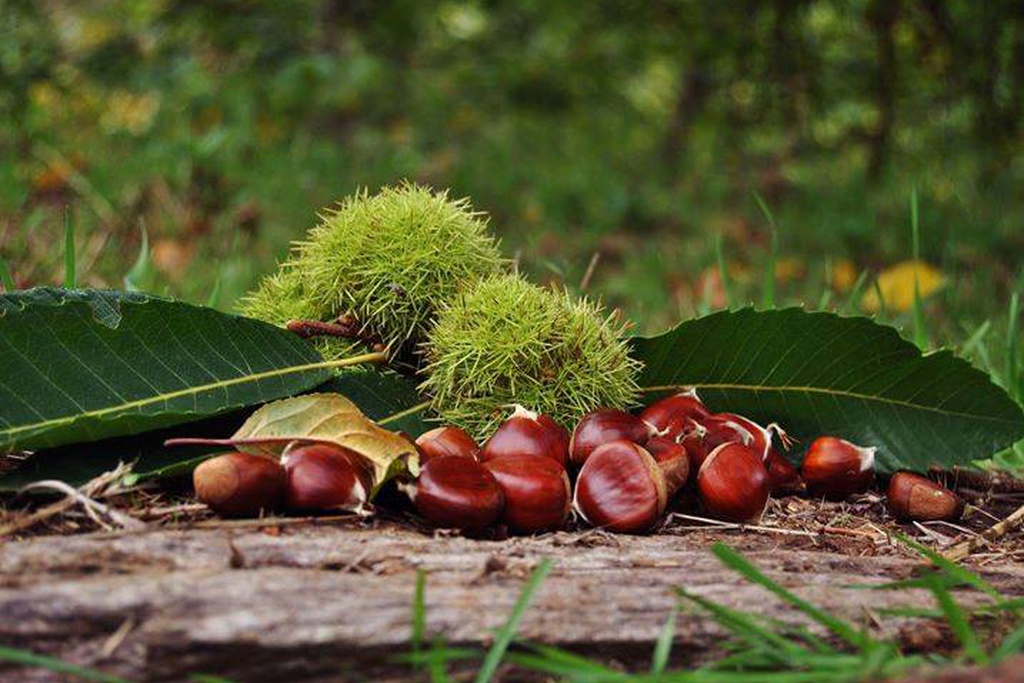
top-left (800, 436), bottom-right (876, 501)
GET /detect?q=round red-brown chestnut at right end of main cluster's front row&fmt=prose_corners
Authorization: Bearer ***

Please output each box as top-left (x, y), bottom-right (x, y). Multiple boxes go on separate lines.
top-left (697, 443), bottom-right (771, 522)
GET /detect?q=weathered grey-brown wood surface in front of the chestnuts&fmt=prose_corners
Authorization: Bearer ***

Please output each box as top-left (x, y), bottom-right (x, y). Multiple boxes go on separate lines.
top-left (0, 523), bottom-right (1024, 682)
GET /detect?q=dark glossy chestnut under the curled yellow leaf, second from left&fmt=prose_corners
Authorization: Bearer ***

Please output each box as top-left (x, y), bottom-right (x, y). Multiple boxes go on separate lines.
top-left (282, 443), bottom-right (373, 512)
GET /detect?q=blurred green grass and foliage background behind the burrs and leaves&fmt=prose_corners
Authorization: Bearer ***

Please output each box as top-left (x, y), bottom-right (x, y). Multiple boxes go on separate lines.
top-left (0, 0), bottom-right (1024, 352)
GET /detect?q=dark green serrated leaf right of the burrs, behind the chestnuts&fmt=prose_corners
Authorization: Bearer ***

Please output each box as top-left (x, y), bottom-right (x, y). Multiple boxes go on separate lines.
top-left (633, 308), bottom-right (1024, 471)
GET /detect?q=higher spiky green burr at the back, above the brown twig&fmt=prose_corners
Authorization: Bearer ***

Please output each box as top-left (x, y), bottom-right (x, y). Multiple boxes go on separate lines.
top-left (242, 183), bottom-right (505, 354)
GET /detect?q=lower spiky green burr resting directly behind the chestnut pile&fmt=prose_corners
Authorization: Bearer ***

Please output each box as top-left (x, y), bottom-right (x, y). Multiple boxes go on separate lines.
top-left (421, 275), bottom-right (640, 440)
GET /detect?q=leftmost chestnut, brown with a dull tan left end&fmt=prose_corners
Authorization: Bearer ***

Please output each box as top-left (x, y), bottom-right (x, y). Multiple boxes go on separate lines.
top-left (193, 453), bottom-right (286, 517)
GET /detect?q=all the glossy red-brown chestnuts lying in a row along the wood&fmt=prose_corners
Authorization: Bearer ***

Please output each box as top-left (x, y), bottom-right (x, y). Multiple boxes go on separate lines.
top-left (194, 391), bottom-right (964, 535)
